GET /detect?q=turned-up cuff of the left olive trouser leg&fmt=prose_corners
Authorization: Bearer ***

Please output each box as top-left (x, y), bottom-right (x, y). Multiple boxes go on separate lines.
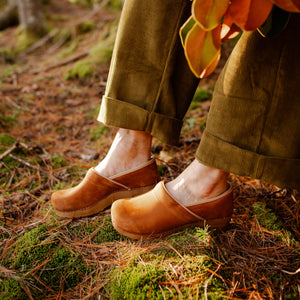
top-left (98, 96), bottom-right (182, 145)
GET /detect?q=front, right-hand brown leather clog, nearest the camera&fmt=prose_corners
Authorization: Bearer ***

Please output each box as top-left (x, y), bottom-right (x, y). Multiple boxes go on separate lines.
top-left (111, 181), bottom-right (233, 239)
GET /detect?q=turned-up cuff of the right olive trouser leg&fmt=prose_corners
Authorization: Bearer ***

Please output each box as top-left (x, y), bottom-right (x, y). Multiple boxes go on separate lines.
top-left (196, 130), bottom-right (300, 190)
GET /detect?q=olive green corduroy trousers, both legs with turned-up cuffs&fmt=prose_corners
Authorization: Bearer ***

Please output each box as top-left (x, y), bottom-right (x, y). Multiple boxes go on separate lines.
top-left (98, 0), bottom-right (300, 189)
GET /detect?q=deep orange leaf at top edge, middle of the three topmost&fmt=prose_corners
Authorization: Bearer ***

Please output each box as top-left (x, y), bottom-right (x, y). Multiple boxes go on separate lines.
top-left (228, 0), bottom-right (273, 30)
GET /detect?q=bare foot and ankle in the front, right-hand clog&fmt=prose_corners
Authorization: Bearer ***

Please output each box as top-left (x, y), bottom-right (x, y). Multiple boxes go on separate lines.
top-left (166, 159), bottom-right (228, 206)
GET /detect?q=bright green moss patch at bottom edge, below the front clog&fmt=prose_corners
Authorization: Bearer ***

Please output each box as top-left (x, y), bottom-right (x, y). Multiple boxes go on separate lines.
top-left (108, 254), bottom-right (226, 300)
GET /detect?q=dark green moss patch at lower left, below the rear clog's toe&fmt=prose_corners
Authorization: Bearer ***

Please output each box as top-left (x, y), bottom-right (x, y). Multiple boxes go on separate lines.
top-left (0, 225), bottom-right (89, 299)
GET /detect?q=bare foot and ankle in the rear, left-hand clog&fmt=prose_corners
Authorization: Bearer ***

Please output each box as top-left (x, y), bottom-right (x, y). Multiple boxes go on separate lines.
top-left (95, 128), bottom-right (152, 177)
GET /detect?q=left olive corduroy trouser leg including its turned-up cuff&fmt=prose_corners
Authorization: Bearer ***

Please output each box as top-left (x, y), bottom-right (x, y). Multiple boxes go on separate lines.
top-left (98, 0), bottom-right (199, 144)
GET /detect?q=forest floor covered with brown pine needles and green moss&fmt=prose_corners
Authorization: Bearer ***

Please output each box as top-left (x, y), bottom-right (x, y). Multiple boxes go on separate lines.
top-left (0, 0), bottom-right (300, 299)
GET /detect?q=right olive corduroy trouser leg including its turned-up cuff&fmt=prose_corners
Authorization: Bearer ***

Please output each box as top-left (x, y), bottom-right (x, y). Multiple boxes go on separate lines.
top-left (196, 14), bottom-right (300, 189)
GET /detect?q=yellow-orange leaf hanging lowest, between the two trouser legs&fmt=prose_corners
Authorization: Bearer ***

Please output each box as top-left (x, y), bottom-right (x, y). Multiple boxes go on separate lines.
top-left (184, 23), bottom-right (221, 78)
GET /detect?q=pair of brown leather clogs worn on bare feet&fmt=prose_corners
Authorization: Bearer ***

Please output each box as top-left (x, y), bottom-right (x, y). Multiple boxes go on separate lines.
top-left (51, 159), bottom-right (233, 239)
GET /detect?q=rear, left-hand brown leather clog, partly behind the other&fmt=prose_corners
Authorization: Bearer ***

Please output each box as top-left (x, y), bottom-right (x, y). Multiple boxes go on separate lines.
top-left (51, 159), bottom-right (160, 217)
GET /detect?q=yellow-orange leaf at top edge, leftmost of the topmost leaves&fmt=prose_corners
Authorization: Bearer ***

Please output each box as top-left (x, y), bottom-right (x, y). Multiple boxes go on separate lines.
top-left (192, 0), bottom-right (229, 30)
